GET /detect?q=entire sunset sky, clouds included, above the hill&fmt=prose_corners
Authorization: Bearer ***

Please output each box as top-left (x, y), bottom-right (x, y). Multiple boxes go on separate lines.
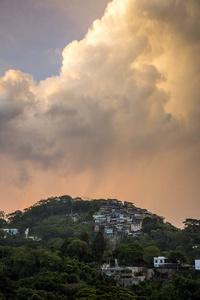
top-left (0, 0), bottom-right (200, 227)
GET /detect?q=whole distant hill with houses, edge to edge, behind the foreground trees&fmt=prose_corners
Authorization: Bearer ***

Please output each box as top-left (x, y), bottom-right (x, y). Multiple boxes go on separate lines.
top-left (0, 195), bottom-right (200, 263)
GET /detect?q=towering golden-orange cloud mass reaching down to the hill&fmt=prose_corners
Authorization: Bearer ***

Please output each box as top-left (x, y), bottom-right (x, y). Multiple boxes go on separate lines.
top-left (0, 0), bottom-right (200, 225)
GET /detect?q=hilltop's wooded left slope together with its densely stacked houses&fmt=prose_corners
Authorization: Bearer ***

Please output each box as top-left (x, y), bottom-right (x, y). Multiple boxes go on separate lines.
top-left (0, 195), bottom-right (156, 244)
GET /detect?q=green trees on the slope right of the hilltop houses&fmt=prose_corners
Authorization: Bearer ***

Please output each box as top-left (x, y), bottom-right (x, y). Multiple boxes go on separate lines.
top-left (134, 217), bottom-right (200, 264)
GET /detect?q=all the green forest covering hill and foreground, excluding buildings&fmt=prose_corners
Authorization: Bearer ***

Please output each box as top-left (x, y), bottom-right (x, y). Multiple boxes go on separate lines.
top-left (0, 195), bottom-right (200, 300)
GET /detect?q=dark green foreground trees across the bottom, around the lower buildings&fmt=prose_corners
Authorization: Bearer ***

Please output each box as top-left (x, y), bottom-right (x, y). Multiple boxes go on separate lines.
top-left (0, 232), bottom-right (200, 300)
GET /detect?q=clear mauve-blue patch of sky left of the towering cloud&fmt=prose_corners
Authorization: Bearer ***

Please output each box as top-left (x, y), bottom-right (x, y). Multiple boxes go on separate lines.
top-left (0, 0), bottom-right (108, 81)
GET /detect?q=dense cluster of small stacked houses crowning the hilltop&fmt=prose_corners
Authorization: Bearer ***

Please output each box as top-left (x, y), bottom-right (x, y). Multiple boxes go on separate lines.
top-left (93, 199), bottom-right (156, 236)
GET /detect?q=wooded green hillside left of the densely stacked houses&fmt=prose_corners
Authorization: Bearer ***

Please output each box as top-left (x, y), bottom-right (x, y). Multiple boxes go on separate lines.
top-left (0, 196), bottom-right (100, 246)
